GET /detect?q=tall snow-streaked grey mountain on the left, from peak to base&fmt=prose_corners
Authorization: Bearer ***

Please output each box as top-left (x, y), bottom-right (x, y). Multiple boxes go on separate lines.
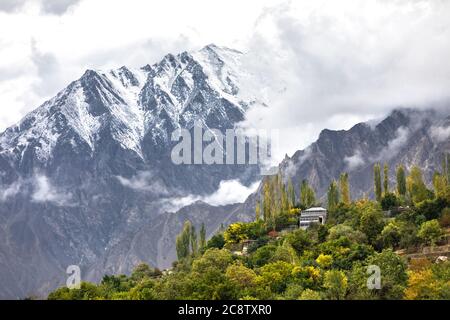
top-left (0, 45), bottom-right (259, 298)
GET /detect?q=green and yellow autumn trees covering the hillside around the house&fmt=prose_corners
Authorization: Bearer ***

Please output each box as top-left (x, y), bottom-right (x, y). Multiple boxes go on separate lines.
top-left (49, 156), bottom-right (450, 300)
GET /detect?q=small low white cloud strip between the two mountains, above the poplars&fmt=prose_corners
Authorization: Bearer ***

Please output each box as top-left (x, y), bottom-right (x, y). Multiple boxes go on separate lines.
top-left (164, 180), bottom-right (260, 212)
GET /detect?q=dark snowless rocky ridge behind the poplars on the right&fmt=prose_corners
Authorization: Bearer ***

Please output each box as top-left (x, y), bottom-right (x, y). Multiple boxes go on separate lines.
top-left (279, 109), bottom-right (450, 202)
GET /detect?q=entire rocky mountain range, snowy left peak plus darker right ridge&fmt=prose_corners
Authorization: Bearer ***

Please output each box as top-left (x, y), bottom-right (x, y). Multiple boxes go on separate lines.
top-left (0, 45), bottom-right (450, 298)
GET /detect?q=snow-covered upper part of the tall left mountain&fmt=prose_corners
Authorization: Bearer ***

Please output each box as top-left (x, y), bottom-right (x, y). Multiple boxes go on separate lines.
top-left (0, 44), bottom-right (257, 163)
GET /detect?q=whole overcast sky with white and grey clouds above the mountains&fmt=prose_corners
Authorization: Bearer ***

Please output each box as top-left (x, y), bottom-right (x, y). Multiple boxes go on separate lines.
top-left (0, 0), bottom-right (450, 160)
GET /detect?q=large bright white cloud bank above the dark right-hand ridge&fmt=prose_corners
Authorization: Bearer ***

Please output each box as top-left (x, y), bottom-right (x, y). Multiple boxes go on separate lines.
top-left (237, 1), bottom-right (450, 159)
